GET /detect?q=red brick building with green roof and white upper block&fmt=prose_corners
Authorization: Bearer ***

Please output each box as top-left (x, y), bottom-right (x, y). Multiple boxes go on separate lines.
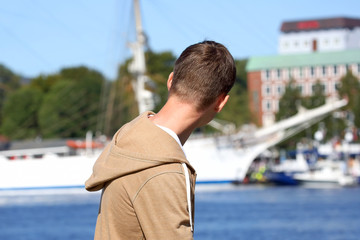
top-left (246, 18), bottom-right (360, 126)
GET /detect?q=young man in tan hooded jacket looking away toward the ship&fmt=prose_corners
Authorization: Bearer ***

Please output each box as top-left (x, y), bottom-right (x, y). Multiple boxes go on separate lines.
top-left (86, 41), bottom-right (236, 240)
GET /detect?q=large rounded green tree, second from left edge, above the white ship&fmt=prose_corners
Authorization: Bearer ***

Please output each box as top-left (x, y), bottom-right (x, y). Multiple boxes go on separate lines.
top-left (39, 67), bottom-right (105, 138)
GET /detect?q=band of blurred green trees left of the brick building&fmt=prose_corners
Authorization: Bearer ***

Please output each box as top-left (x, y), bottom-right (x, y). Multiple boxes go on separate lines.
top-left (0, 51), bottom-right (264, 139)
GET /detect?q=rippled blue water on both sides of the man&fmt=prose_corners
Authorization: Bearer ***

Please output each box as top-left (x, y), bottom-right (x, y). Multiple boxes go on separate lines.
top-left (0, 186), bottom-right (360, 240)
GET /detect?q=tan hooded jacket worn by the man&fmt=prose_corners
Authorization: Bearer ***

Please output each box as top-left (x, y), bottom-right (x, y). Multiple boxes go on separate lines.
top-left (85, 112), bottom-right (196, 240)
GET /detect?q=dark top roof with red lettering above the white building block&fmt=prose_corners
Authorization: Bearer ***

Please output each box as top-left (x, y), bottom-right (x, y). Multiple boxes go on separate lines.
top-left (281, 17), bottom-right (360, 33)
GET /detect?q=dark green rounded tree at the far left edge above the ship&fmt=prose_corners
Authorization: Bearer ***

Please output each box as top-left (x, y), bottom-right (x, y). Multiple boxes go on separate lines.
top-left (1, 87), bottom-right (43, 139)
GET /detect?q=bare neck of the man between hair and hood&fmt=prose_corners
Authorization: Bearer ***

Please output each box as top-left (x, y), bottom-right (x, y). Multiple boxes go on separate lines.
top-left (150, 98), bottom-right (201, 145)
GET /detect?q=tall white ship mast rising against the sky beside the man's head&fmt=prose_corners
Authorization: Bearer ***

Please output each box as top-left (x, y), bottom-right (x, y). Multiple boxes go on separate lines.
top-left (129, 0), bottom-right (155, 113)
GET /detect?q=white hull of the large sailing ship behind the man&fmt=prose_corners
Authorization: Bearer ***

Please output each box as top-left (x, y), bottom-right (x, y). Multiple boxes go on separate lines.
top-left (0, 138), bottom-right (252, 190)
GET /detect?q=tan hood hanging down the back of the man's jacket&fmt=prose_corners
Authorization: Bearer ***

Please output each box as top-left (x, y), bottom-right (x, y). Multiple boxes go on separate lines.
top-left (85, 112), bottom-right (193, 191)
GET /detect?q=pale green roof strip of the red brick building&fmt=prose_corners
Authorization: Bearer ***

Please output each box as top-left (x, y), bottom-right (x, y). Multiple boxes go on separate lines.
top-left (246, 49), bottom-right (360, 72)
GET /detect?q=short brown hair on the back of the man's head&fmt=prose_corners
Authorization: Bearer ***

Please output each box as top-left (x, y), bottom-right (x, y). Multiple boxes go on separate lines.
top-left (169, 41), bottom-right (236, 110)
